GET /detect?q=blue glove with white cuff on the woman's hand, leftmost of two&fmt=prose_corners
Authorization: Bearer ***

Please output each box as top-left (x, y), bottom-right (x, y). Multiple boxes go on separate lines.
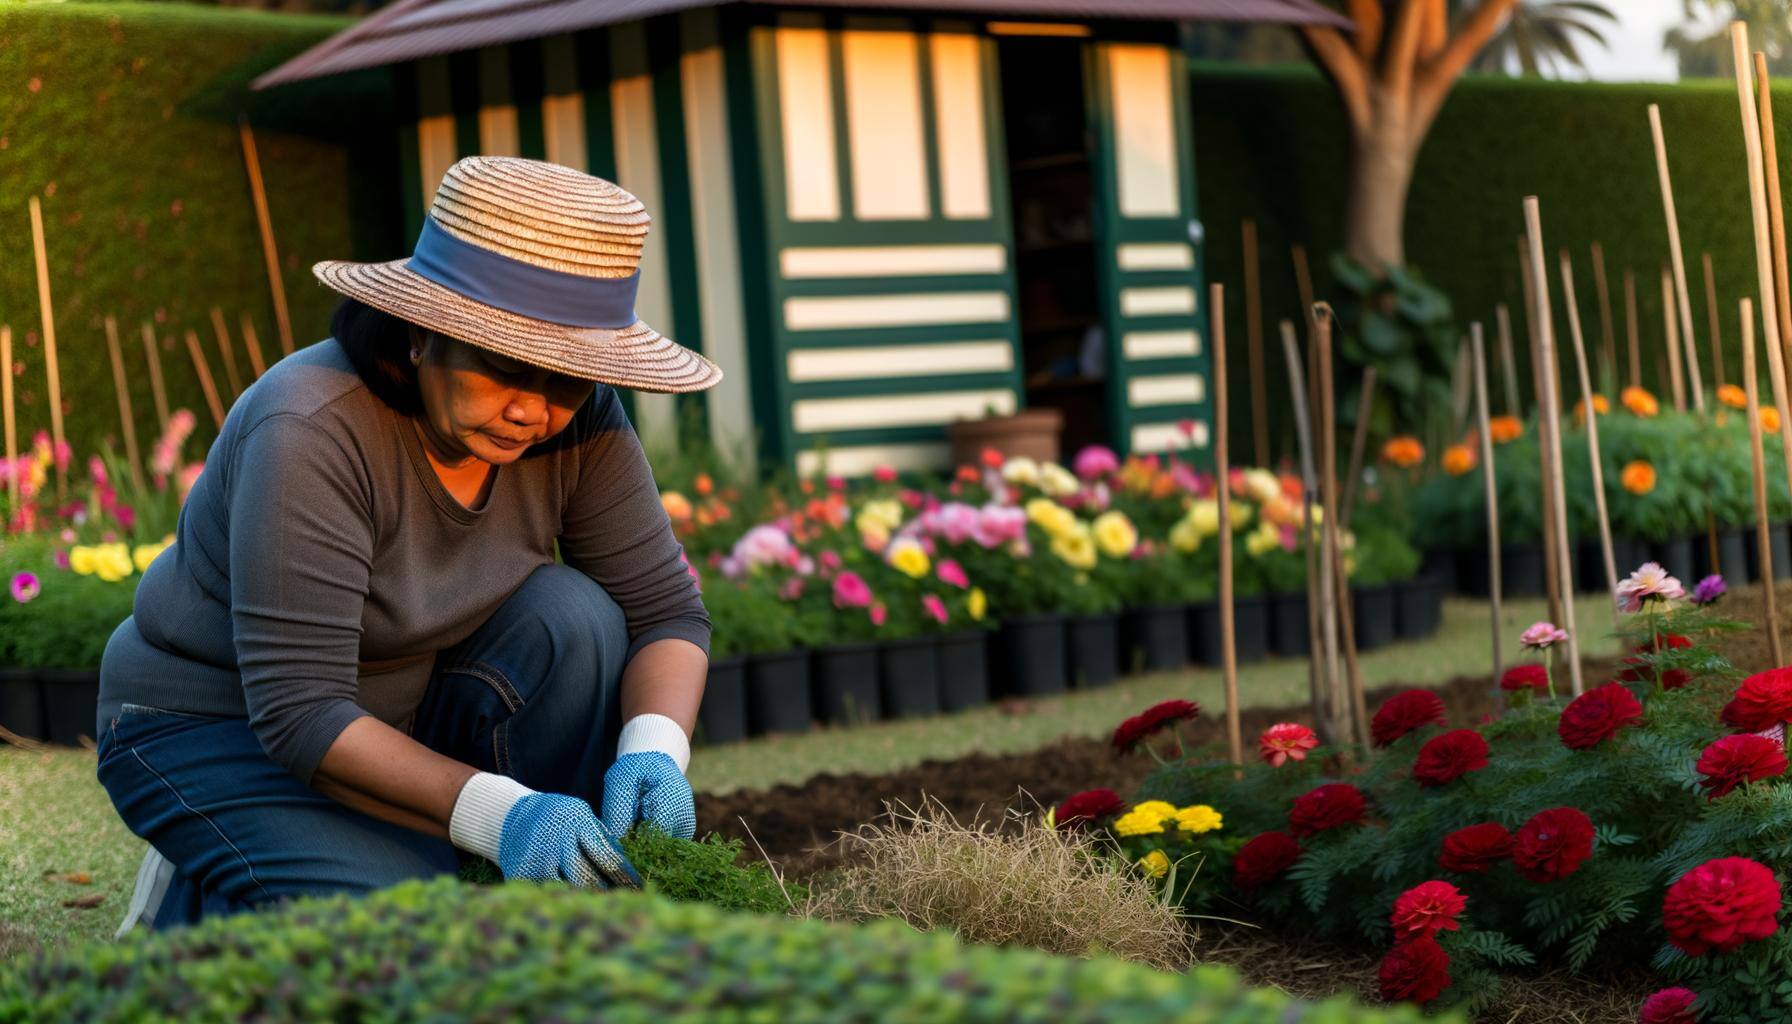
top-left (448, 771), bottom-right (642, 889)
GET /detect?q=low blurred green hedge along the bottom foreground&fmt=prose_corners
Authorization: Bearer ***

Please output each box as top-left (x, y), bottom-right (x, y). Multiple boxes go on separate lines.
top-left (0, 881), bottom-right (1419, 1024)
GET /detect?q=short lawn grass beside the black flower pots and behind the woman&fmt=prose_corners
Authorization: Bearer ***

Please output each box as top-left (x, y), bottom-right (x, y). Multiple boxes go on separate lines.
top-left (0, 597), bottom-right (1616, 959)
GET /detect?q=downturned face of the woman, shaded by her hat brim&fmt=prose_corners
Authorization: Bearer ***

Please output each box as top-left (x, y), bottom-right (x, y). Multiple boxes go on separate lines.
top-left (410, 326), bottom-right (593, 466)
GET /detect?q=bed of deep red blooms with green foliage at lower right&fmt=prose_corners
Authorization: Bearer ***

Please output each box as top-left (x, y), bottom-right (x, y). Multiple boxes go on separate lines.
top-left (1060, 567), bottom-right (1792, 1024)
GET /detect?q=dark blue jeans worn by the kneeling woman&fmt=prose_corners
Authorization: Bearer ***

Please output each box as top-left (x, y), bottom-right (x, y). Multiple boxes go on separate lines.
top-left (99, 565), bottom-right (629, 931)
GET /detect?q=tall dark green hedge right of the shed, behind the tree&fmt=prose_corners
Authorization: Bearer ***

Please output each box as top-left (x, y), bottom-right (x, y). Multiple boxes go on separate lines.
top-left (1190, 63), bottom-right (1792, 452)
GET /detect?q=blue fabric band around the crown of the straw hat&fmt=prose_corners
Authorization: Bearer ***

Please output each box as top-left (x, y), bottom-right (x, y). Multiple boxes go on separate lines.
top-left (405, 217), bottom-right (642, 330)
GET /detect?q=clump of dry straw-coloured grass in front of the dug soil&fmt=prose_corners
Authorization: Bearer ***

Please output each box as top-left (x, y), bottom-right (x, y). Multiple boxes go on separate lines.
top-left (797, 800), bottom-right (1190, 970)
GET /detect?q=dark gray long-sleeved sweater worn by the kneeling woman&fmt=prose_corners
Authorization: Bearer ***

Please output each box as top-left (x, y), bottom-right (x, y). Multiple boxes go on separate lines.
top-left (95, 339), bottom-right (710, 782)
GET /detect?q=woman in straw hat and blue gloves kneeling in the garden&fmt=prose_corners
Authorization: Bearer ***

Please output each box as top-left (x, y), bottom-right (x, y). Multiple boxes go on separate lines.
top-left (95, 158), bottom-right (720, 933)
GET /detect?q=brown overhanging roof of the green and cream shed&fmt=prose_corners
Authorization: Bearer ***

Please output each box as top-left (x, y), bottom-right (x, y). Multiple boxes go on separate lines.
top-left (253, 0), bottom-right (1349, 90)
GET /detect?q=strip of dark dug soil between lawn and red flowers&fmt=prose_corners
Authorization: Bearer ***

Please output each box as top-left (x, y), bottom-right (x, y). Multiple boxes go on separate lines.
top-left (697, 676), bottom-right (1512, 879)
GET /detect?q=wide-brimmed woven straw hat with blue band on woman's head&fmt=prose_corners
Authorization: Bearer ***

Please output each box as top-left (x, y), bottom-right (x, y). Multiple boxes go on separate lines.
top-left (312, 156), bottom-right (722, 393)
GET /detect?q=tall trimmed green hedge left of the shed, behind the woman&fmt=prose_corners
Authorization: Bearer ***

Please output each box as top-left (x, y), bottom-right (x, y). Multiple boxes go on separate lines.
top-left (0, 4), bottom-right (400, 457)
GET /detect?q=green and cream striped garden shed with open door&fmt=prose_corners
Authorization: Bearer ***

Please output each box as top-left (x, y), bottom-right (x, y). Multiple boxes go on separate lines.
top-left (256, 0), bottom-right (1342, 475)
